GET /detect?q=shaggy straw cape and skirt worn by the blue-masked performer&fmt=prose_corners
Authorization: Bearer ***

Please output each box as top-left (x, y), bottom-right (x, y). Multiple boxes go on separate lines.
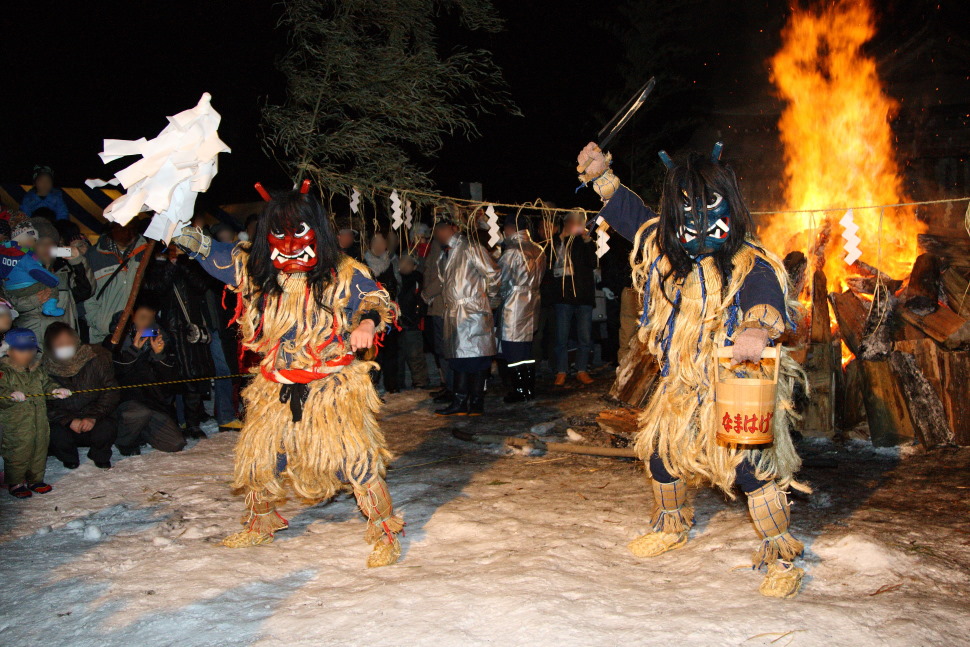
top-left (631, 218), bottom-right (808, 497)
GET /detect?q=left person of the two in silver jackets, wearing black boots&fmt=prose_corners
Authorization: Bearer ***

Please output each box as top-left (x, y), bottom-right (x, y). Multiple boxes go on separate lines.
top-left (434, 222), bottom-right (499, 416)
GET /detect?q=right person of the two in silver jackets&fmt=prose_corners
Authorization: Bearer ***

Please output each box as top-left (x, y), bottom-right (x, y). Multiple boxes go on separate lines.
top-left (498, 214), bottom-right (546, 402)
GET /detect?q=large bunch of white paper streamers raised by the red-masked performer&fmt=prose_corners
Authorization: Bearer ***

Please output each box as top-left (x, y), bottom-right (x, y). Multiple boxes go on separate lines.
top-left (85, 92), bottom-right (231, 244)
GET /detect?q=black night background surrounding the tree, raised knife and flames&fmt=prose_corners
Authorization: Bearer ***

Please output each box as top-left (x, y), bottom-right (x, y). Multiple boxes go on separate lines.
top-left (0, 0), bottom-right (970, 216)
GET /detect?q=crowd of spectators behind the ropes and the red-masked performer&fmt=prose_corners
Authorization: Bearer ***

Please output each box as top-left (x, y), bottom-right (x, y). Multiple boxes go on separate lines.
top-left (0, 166), bottom-right (637, 498)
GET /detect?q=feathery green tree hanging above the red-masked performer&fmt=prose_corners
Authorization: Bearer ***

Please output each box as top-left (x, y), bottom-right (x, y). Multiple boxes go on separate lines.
top-left (263, 0), bottom-right (517, 193)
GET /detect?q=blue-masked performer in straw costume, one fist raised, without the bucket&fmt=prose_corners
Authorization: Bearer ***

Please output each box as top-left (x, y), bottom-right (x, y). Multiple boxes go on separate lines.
top-left (579, 143), bottom-right (808, 597)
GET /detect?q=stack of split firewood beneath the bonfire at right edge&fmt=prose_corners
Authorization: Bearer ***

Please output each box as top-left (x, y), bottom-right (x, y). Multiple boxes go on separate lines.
top-left (806, 252), bottom-right (970, 448)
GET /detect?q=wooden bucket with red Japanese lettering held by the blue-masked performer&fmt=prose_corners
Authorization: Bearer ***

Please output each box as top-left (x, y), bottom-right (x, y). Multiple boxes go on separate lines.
top-left (714, 345), bottom-right (781, 445)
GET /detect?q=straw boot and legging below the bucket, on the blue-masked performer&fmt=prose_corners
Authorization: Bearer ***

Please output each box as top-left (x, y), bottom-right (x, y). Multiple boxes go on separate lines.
top-left (748, 481), bottom-right (805, 598)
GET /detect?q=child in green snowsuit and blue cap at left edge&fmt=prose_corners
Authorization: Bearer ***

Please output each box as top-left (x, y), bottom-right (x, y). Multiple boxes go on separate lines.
top-left (0, 328), bottom-right (71, 499)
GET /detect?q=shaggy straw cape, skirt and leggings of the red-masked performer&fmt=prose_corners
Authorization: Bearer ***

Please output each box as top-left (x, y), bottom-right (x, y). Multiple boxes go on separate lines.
top-left (225, 245), bottom-right (404, 565)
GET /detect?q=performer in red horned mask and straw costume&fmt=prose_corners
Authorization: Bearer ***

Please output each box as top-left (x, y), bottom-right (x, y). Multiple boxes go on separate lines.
top-left (174, 183), bottom-right (404, 567)
